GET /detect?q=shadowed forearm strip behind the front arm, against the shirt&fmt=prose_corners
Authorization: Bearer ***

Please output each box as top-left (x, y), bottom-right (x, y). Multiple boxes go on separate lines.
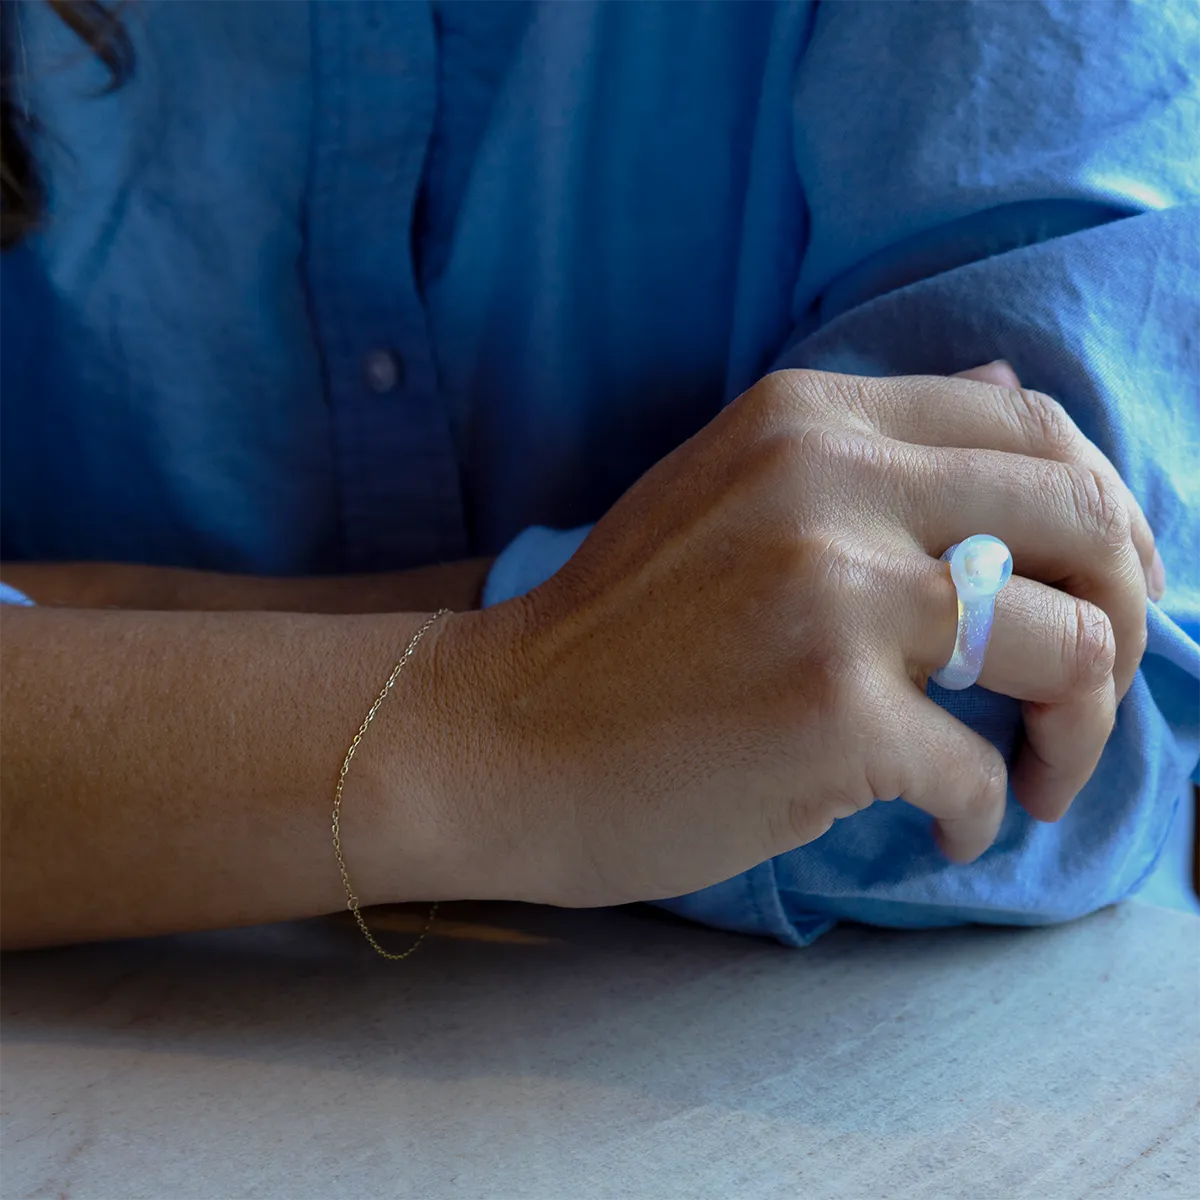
top-left (0, 558), bottom-right (490, 613)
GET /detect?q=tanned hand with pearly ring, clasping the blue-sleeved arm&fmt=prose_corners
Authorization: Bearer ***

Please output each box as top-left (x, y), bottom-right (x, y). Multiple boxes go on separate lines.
top-left (448, 368), bottom-right (1154, 905)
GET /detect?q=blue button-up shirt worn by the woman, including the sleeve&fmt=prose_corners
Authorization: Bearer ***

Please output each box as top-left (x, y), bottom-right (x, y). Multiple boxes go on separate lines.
top-left (0, 0), bottom-right (1200, 943)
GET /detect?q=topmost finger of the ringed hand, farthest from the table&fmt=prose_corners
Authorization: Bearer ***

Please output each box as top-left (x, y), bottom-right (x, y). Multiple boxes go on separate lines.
top-left (857, 374), bottom-right (1165, 600)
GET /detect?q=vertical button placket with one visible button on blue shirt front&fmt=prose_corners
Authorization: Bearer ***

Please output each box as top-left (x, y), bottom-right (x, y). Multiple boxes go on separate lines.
top-left (306, 0), bottom-right (469, 571)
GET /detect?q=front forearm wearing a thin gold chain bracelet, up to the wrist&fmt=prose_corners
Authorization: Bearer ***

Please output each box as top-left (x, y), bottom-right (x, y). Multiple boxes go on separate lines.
top-left (0, 610), bottom-right (499, 948)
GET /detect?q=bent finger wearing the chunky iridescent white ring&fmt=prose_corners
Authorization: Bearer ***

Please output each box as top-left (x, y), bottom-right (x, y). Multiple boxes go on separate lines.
top-left (914, 571), bottom-right (1117, 821)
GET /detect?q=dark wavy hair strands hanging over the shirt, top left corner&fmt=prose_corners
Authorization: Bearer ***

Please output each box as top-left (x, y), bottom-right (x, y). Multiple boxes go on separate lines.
top-left (0, 0), bottom-right (133, 250)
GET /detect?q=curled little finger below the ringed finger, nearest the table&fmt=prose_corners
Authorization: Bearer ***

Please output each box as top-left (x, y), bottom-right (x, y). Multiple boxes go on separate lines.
top-left (870, 689), bottom-right (1008, 863)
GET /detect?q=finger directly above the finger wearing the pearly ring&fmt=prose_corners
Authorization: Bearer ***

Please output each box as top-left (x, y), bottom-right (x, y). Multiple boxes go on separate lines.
top-left (892, 448), bottom-right (1146, 698)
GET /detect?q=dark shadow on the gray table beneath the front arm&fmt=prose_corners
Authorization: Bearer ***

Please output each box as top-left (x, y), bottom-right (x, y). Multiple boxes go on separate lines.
top-left (0, 905), bottom-right (1112, 1093)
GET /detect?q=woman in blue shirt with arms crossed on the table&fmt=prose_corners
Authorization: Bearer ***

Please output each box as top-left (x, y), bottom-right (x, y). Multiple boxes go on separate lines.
top-left (0, 0), bottom-right (1200, 946)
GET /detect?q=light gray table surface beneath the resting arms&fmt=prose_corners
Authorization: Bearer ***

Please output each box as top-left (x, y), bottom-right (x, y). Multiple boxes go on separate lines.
top-left (0, 905), bottom-right (1200, 1200)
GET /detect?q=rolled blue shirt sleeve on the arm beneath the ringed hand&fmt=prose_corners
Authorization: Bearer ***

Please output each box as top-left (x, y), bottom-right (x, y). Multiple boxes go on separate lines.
top-left (488, 0), bottom-right (1200, 944)
